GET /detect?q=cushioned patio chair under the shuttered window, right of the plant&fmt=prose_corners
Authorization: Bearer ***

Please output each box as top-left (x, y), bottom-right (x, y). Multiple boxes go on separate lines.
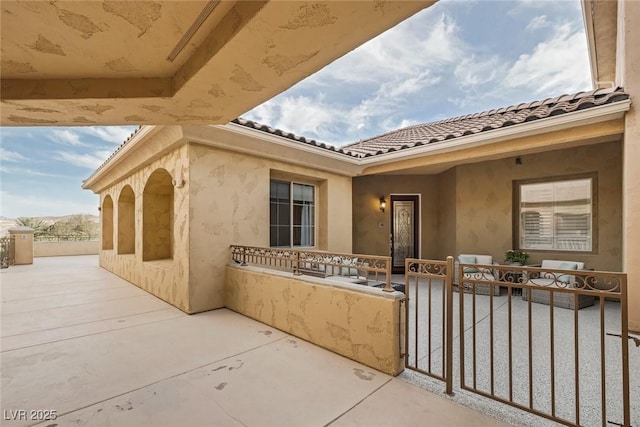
top-left (522, 259), bottom-right (595, 310)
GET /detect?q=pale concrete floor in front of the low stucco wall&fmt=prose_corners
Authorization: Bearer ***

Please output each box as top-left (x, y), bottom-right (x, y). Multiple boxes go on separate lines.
top-left (0, 256), bottom-right (507, 427)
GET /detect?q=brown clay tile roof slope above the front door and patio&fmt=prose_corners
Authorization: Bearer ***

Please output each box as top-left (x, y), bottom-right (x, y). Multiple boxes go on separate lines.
top-left (342, 88), bottom-right (629, 158)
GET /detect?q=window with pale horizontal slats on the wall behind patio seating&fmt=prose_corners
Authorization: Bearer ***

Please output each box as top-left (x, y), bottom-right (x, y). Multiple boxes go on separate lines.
top-left (516, 178), bottom-right (594, 252)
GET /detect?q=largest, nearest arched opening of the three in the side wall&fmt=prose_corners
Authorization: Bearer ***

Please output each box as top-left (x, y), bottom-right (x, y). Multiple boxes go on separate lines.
top-left (142, 169), bottom-right (173, 261)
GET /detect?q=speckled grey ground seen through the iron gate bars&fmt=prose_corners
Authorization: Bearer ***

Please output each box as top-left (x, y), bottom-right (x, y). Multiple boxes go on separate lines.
top-left (401, 280), bottom-right (640, 426)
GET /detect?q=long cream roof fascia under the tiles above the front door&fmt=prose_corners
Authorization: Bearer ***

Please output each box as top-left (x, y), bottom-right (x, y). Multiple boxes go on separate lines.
top-left (360, 99), bottom-right (631, 167)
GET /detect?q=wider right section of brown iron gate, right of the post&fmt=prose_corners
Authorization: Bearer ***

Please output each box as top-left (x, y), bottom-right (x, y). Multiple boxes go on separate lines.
top-left (456, 263), bottom-right (630, 426)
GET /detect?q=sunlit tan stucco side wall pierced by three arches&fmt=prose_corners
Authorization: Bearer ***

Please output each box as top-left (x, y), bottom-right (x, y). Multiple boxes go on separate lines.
top-left (100, 145), bottom-right (193, 313)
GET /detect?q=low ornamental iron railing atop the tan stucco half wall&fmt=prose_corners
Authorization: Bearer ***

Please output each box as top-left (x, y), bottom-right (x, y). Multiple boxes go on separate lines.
top-left (231, 245), bottom-right (394, 291)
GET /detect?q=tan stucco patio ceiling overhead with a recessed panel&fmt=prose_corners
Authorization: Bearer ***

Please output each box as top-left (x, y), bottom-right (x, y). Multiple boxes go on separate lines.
top-left (1, 0), bottom-right (434, 126)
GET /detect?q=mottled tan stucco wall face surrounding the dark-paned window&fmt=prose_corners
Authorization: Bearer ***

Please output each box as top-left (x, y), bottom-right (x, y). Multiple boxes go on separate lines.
top-left (189, 144), bottom-right (351, 312)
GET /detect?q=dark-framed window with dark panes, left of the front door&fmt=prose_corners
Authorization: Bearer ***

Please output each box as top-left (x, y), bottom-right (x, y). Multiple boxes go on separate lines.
top-left (269, 180), bottom-right (315, 247)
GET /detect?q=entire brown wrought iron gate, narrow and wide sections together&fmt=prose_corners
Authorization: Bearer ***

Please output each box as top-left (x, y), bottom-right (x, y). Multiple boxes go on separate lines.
top-left (404, 257), bottom-right (640, 426)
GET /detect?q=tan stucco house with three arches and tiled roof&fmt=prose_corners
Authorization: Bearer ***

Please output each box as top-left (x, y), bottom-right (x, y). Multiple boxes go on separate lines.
top-left (84, 89), bottom-right (630, 324)
